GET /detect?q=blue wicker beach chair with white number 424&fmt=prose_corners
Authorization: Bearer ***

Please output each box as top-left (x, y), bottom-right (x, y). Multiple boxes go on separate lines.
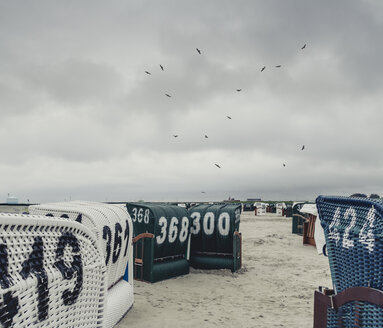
top-left (314, 196), bottom-right (383, 328)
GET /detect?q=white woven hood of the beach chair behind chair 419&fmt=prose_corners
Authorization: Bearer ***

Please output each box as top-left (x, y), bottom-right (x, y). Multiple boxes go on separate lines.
top-left (29, 201), bottom-right (133, 288)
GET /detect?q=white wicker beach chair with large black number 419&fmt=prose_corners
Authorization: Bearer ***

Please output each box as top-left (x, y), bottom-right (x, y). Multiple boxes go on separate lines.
top-left (0, 214), bottom-right (106, 328)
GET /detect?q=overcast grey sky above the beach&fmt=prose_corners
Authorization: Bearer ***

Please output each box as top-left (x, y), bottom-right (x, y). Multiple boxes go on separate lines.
top-left (0, 0), bottom-right (383, 202)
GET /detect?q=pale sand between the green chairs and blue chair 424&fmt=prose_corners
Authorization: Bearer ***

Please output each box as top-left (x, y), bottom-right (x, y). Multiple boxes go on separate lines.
top-left (116, 212), bottom-right (331, 328)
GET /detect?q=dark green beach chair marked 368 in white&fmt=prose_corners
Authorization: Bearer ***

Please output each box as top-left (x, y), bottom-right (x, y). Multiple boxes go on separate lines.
top-left (126, 203), bottom-right (190, 282)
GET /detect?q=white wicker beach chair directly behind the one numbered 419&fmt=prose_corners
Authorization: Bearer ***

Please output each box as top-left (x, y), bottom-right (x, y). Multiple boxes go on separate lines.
top-left (29, 201), bottom-right (134, 327)
